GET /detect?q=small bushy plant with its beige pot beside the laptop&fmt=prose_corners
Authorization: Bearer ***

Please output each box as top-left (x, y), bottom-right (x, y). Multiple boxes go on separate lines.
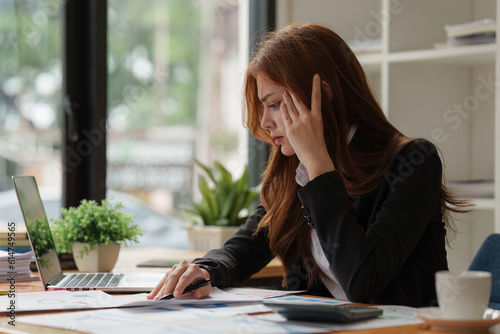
top-left (52, 198), bottom-right (143, 271)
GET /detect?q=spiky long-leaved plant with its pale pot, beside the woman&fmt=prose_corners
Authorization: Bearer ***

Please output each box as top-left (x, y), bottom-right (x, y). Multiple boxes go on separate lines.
top-left (184, 161), bottom-right (259, 252)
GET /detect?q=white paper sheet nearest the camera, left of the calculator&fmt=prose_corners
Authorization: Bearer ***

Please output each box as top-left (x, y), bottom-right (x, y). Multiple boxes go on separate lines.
top-left (18, 306), bottom-right (330, 334)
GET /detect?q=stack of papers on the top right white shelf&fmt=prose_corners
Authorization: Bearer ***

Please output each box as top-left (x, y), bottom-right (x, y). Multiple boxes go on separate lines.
top-left (444, 19), bottom-right (497, 45)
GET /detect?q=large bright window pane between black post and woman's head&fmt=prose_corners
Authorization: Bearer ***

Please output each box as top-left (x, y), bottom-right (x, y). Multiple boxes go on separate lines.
top-left (107, 0), bottom-right (248, 246)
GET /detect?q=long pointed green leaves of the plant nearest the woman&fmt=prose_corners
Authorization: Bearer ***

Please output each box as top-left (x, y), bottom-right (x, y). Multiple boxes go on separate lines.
top-left (184, 161), bottom-right (259, 226)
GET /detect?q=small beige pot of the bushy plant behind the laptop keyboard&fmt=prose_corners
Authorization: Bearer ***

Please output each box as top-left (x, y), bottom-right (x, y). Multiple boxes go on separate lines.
top-left (73, 242), bottom-right (121, 272)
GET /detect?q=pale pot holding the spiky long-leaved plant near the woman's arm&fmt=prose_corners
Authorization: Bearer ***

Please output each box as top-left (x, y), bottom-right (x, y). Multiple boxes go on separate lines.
top-left (187, 226), bottom-right (239, 252)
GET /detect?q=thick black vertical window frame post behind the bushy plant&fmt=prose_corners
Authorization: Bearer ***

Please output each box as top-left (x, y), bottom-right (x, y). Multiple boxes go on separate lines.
top-left (61, 0), bottom-right (108, 208)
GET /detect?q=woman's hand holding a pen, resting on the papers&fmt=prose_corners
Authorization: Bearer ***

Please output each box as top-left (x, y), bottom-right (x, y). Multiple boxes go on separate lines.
top-left (147, 260), bottom-right (212, 300)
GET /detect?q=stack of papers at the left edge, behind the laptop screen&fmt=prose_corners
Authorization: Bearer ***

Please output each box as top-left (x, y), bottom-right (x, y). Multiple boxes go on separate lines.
top-left (0, 249), bottom-right (35, 282)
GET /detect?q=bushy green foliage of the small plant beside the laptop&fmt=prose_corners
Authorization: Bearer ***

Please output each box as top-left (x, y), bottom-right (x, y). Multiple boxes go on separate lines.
top-left (52, 198), bottom-right (143, 257)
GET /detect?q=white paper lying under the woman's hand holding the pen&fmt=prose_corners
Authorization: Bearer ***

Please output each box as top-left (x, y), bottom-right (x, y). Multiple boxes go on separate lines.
top-left (0, 288), bottom-right (304, 313)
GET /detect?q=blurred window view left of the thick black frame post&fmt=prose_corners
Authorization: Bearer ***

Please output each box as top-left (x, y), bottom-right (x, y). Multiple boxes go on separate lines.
top-left (0, 0), bottom-right (62, 191)
